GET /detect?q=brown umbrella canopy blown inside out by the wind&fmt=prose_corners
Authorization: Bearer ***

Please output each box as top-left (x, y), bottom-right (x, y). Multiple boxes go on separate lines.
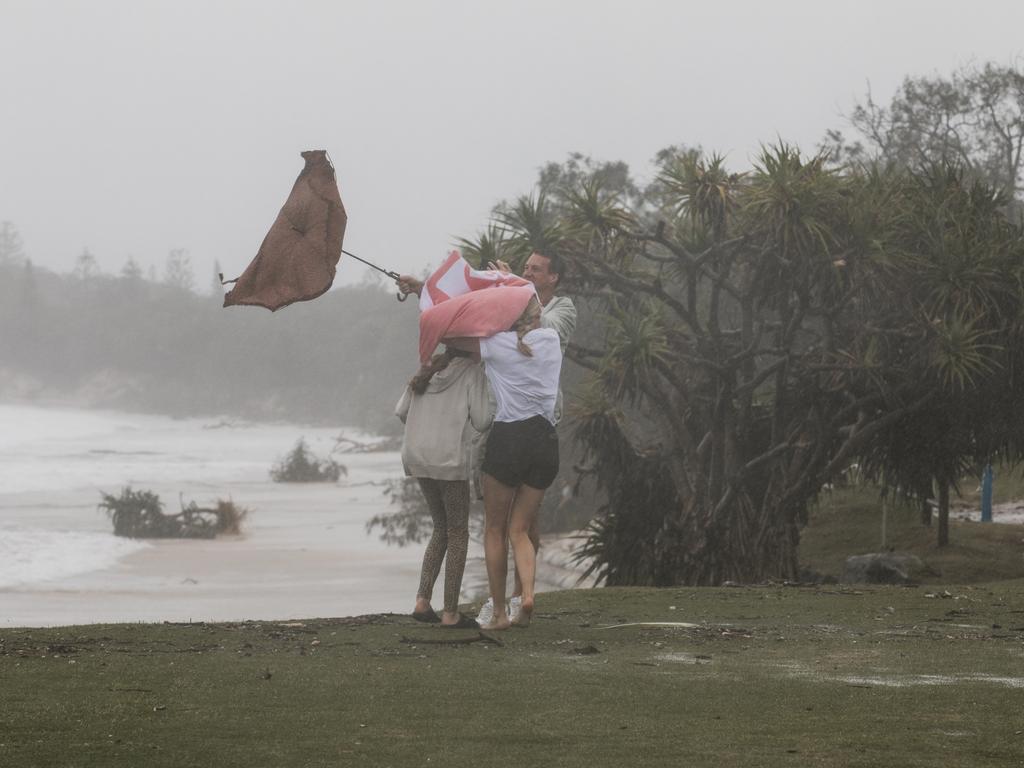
top-left (224, 150), bottom-right (348, 311)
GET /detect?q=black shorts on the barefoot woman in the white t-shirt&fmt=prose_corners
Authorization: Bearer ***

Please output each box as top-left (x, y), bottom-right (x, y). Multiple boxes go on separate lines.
top-left (480, 416), bottom-right (558, 490)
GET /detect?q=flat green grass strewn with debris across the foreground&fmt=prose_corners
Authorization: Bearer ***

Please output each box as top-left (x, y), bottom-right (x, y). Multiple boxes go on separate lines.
top-left (0, 582), bottom-right (1024, 768)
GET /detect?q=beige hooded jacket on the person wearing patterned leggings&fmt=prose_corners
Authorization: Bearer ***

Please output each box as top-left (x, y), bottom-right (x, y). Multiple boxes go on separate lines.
top-left (394, 357), bottom-right (495, 480)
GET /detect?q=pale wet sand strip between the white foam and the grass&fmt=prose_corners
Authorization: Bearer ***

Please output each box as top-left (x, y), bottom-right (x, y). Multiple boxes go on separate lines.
top-left (0, 526), bottom-right (594, 629)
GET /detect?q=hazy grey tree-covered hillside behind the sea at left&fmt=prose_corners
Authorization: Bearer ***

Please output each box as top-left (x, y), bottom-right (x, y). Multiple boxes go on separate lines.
top-left (0, 260), bottom-right (418, 431)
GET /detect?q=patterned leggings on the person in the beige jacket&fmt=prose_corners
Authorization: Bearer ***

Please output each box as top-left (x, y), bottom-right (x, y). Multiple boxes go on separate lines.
top-left (417, 477), bottom-right (469, 613)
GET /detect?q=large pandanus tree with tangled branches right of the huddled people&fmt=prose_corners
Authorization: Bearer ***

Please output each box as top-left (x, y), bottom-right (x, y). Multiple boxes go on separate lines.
top-left (466, 144), bottom-right (1022, 585)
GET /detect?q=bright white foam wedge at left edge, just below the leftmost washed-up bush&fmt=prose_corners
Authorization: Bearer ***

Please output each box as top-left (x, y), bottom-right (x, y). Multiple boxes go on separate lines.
top-left (0, 528), bottom-right (150, 588)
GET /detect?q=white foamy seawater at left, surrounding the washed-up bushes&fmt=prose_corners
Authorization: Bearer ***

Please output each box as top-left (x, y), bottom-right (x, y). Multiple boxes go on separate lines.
top-left (0, 404), bottom-right (387, 589)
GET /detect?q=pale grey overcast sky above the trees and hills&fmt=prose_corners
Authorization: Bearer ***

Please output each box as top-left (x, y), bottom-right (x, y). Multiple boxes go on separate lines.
top-left (0, 0), bottom-right (1024, 290)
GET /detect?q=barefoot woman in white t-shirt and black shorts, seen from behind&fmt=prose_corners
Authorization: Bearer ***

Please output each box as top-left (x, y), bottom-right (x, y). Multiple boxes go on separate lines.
top-left (480, 297), bottom-right (562, 630)
